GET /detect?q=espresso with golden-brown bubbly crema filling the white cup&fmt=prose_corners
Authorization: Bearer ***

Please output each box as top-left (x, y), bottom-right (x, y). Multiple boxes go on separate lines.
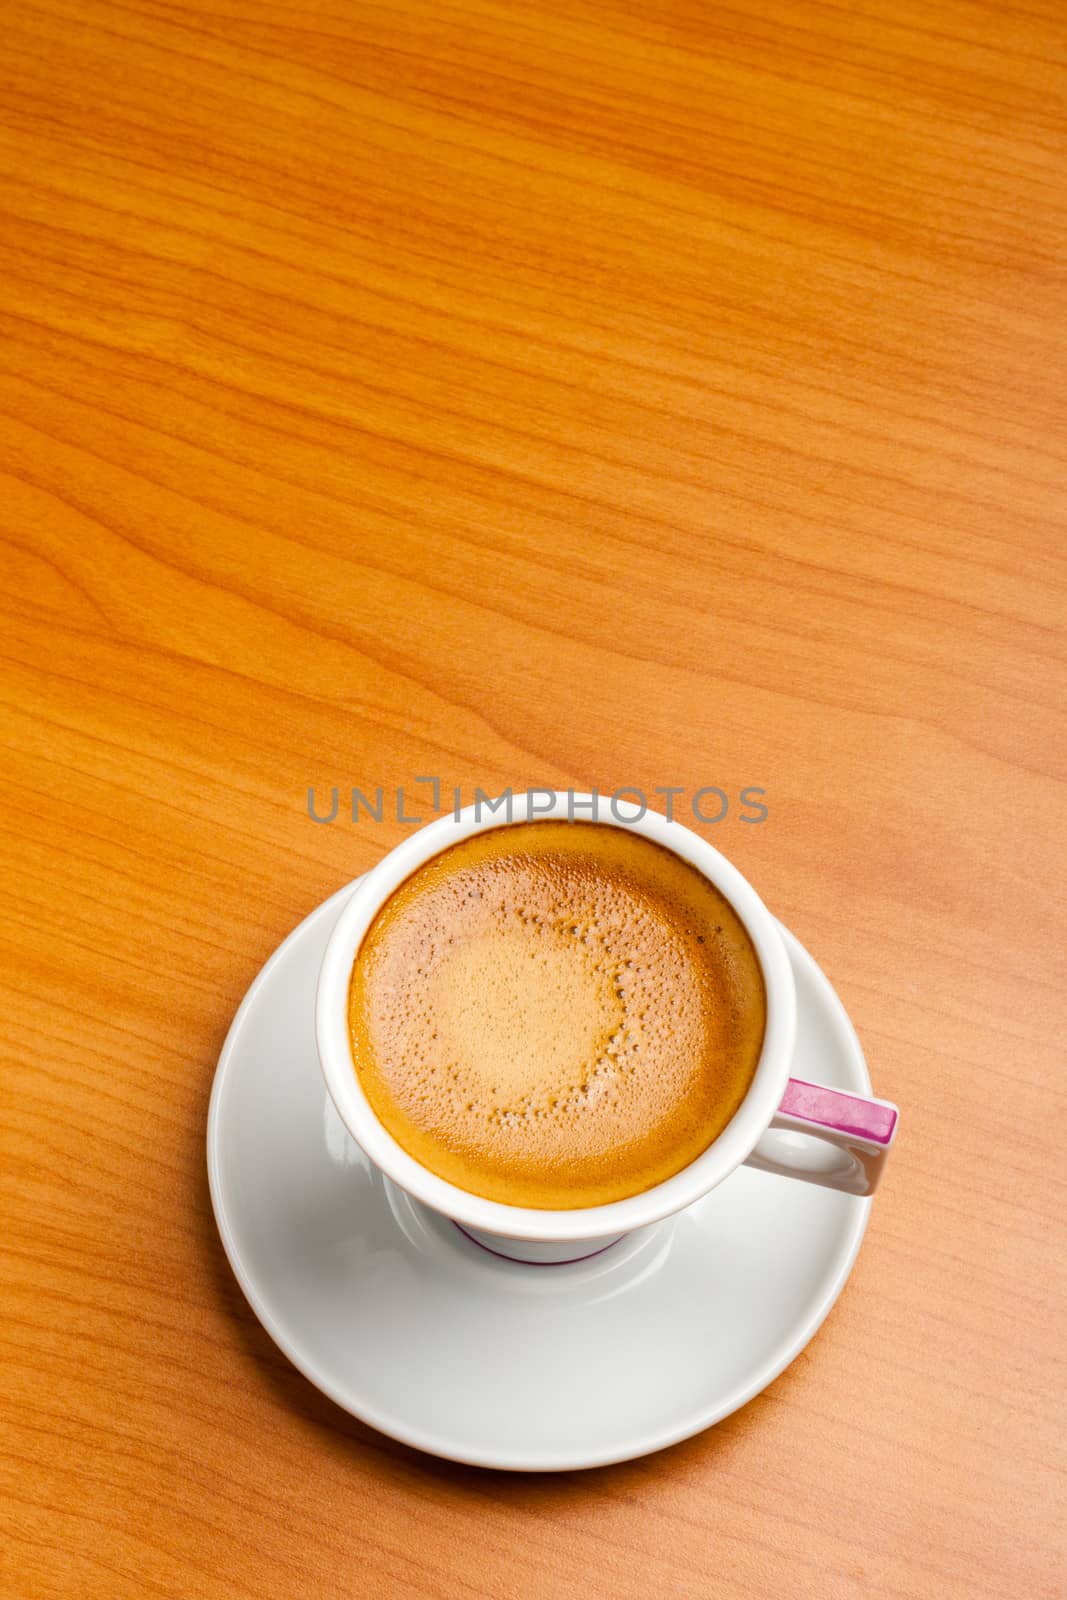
top-left (349, 822), bottom-right (766, 1210)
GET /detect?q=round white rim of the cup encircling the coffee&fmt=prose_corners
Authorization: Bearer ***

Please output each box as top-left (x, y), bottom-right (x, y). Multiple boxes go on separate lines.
top-left (315, 789), bottom-right (797, 1243)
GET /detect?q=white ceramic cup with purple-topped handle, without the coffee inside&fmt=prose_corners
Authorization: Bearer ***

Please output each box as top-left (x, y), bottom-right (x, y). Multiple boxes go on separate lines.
top-left (315, 789), bottom-right (897, 1264)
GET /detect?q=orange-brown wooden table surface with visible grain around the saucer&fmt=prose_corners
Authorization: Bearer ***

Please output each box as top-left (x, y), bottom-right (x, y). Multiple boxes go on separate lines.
top-left (0, 0), bottom-right (1067, 1600)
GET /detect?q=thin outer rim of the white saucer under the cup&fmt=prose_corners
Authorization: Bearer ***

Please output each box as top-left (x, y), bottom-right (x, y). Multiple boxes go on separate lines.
top-left (206, 883), bottom-right (870, 1472)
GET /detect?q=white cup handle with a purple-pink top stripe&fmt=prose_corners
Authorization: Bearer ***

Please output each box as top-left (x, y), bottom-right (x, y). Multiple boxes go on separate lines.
top-left (745, 1078), bottom-right (899, 1195)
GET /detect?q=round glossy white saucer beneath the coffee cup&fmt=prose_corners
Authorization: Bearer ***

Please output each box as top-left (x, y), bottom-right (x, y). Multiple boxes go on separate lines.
top-left (208, 890), bottom-right (870, 1472)
